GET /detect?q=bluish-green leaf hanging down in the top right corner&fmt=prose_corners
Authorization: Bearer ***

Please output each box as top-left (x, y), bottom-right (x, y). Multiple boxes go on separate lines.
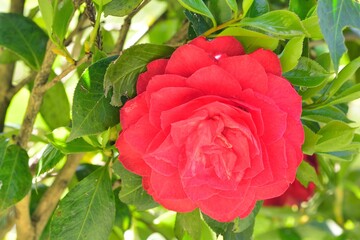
top-left (317, 0), bottom-right (360, 71)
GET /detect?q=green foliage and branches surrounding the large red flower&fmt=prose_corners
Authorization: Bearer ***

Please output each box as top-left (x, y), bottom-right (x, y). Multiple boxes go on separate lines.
top-left (0, 0), bottom-right (360, 240)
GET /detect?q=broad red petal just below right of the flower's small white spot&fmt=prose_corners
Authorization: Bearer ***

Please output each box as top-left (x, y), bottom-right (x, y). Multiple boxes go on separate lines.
top-left (219, 55), bottom-right (268, 93)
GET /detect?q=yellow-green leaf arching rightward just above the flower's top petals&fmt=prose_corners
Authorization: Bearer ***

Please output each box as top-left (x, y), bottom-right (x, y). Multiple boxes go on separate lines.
top-left (218, 27), bottom-right (279, 52)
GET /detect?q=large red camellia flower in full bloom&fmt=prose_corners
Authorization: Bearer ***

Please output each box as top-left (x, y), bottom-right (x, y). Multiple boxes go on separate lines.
top-left (116, 37), bottom-right (304, 222)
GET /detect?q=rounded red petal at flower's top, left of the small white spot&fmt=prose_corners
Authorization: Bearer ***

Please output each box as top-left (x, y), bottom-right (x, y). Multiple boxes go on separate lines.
top-left (165, 44), bottom-right (215, 77)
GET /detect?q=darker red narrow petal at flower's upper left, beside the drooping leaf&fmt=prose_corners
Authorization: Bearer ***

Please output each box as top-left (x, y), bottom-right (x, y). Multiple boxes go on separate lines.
top-left (136, 59), bottom-right (168, 94)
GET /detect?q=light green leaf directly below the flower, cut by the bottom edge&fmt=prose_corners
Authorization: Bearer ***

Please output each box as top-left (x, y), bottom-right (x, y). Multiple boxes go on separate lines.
top-left (175, 209), bottom-right (202, 239)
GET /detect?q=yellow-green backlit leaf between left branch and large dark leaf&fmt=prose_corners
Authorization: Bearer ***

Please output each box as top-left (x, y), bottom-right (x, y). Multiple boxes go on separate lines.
top-left (40, 82), bottom-right (70, 129)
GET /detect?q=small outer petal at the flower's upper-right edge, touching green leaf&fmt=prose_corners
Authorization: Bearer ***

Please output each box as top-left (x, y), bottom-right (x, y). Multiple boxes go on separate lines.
top-left (249, 48), bottom-right (281, 76)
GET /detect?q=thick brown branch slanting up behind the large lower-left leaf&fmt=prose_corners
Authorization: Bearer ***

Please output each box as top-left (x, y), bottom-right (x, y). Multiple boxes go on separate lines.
top-left (31, 154), bottom-right (83, 239)
